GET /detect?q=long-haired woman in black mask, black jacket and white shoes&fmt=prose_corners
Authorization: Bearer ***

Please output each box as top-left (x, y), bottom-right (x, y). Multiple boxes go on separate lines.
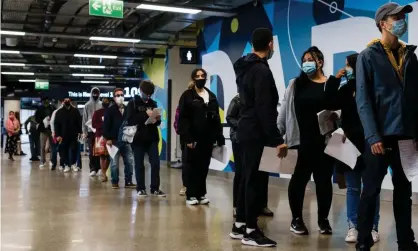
top-left (178, 69), bottom-right (225, 205)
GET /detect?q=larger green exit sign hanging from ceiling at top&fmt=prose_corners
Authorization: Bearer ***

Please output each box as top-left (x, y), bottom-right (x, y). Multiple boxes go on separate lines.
top-left (89, 0), bottom-right (123, 18)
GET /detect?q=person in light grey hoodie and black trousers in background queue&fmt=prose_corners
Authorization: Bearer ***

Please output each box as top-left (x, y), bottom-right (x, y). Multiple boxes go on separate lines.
top-left (82, 87), bottom-right (102, 176)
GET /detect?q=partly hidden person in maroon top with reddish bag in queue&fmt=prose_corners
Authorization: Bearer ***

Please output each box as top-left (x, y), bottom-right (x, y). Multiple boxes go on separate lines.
top-left (91, 98), bottom-right (110, 182)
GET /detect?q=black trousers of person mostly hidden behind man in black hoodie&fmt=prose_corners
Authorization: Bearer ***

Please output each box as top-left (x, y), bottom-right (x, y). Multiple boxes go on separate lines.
top-left (232, 142), bottom-right (269, 210)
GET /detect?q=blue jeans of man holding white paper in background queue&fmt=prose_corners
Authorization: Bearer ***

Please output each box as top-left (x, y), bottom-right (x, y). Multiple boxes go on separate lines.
top-left (110, 143), bottom-right (134, 184)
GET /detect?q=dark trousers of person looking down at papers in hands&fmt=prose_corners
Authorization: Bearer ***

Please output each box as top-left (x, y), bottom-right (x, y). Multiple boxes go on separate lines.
top-left (132, 142), bottom-right (160, 192)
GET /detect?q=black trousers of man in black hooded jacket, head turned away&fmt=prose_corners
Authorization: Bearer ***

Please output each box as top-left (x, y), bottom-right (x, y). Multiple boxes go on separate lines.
top-left (236, 142), bottom-right (269, 228)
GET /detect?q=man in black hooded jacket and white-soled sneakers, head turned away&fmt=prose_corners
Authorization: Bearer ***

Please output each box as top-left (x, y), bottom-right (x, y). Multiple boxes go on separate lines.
top-left (230, 28), bottom-right (286, 247)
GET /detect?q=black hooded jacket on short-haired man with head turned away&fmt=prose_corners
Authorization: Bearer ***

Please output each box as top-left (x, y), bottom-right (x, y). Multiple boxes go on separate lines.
top-left (234, 53), bottom-right (284, 147)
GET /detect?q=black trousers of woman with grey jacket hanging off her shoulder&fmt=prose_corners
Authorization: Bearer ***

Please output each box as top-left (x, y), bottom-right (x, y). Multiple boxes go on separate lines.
top-left (288, 142), bottom-right (334, 222)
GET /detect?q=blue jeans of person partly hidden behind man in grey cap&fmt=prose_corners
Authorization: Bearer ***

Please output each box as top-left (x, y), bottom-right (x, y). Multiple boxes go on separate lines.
top-left (345, 170), bottom-right (380, 231)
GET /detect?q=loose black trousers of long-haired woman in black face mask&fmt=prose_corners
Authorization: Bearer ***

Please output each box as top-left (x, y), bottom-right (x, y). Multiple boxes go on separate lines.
top-left (185, 142), bottom-right (213, 199)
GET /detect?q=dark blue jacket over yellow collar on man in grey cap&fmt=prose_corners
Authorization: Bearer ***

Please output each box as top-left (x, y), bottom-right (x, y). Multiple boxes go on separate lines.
top-left (356, 40), bottom-right (418, 145)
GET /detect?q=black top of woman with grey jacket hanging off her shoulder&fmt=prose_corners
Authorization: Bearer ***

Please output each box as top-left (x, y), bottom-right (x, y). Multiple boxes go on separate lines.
top-left (295, 80), bottom-right (326, 144)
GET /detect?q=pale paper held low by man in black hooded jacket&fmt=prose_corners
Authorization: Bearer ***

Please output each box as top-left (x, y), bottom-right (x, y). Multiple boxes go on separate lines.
top-left (258, 147), bottom-right (298, 174)
